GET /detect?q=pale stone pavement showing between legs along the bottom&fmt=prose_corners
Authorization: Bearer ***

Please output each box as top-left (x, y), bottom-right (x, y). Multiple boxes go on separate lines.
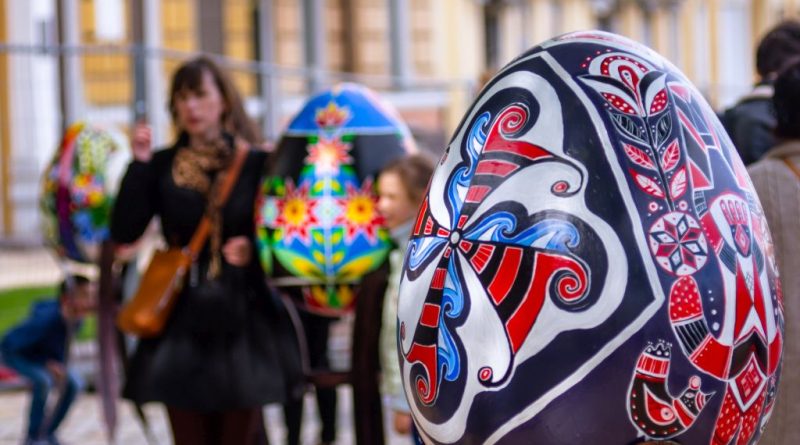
top-left (0, 387), bottom-right (411, 445)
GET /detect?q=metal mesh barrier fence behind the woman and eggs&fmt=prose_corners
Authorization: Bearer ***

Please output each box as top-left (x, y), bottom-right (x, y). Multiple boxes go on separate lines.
top-left (0, 43), bottom-right (476, 244)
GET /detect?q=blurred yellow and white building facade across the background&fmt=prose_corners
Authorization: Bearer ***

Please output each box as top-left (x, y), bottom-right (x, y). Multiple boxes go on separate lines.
top-left (0, 0), bottom-right (800, 242)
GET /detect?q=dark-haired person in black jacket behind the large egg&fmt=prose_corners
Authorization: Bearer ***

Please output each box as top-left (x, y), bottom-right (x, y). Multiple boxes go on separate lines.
top-left (720, 20), bottom-right (800, 165)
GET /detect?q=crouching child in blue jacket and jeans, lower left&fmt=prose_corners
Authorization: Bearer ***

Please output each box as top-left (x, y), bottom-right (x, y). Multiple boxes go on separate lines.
top-left (0, 275), bottom-right (94, 445)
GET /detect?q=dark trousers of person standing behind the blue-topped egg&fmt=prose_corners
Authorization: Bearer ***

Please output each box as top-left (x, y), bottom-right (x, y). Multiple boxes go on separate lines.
top-left (283, 312), bottom-right (336, 445)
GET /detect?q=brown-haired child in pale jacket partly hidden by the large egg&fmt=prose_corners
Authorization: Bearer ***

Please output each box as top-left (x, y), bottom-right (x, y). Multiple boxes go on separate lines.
top-left (378, 154), bottom-right (434, 434)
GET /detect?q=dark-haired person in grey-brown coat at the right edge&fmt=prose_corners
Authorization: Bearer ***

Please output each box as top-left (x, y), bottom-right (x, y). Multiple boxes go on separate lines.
top-left (748, 59), bottom-right (800, 445)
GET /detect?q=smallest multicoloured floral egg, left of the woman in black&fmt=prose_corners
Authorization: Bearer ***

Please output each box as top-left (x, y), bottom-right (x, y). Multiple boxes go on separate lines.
top-left (39, 122), bottom-right (130, 263)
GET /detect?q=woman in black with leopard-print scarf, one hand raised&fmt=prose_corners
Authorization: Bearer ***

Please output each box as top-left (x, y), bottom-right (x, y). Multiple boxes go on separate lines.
top-left (111, 57), bottom-right (300, 445)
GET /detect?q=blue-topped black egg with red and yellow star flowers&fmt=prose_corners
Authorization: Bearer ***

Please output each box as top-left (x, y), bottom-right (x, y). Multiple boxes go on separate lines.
top-left (257, 84), bottom-right (415, 316)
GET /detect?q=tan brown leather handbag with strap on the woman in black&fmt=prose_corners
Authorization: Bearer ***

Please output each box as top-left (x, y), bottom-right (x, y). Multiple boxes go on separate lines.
top-left (117, 141), bottom-right (248, 338)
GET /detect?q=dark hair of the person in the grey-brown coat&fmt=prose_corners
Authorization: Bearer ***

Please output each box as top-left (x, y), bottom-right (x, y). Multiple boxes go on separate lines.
top-left (772, 57), bottom-right (800, 139)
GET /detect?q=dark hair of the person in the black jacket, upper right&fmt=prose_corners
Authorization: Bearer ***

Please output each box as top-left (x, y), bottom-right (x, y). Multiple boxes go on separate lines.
top-left (756, 20), bottom-right (800, 79)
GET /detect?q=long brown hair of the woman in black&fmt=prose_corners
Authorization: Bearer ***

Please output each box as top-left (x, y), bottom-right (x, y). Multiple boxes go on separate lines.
top-left (169, 56), bottom-right (261, 144)
